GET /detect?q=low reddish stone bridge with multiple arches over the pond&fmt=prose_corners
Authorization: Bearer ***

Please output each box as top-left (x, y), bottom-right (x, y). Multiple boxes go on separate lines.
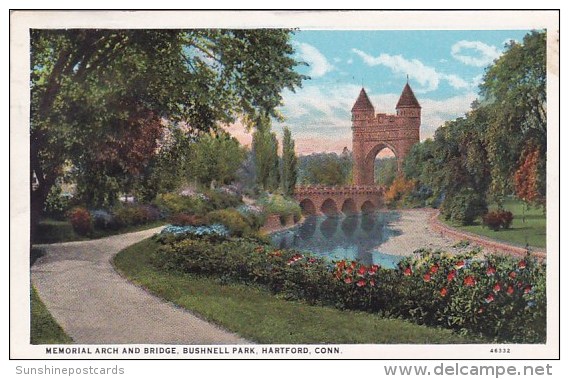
top-left (294, 186), bottom-right (384, 216)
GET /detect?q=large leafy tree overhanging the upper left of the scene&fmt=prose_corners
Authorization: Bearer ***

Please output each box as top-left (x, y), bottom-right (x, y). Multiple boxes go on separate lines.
top-left (30, 29), bottom-right (305, 235)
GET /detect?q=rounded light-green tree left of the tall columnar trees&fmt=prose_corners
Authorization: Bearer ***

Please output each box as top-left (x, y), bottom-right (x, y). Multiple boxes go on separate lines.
top-left (187, 132), bottom-right (245, 186)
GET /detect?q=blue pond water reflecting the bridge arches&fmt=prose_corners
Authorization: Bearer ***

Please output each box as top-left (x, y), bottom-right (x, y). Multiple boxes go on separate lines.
top-left (271, 212), bottom-right (402, 268)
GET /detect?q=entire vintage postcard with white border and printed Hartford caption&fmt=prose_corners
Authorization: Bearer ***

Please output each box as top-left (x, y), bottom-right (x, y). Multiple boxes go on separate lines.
top-left (10, 11), bottom-right (560, 360)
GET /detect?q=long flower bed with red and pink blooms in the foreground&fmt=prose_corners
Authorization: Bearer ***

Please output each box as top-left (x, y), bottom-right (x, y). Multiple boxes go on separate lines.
top-left (155, 233), bottom-right (546, 343)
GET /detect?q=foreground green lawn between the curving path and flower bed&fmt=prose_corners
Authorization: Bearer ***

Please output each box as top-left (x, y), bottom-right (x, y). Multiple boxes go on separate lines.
top-left (114, 239), bottom-right (480, 344)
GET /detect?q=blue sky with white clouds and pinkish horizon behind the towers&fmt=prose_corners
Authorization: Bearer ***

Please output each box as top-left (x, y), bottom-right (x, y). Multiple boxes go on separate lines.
top-left (227, 30), bottom-right (529, 154)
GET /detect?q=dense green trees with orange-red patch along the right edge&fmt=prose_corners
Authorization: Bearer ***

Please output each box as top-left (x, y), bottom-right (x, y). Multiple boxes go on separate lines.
top-left (403, 31), bottom-right (547, 224)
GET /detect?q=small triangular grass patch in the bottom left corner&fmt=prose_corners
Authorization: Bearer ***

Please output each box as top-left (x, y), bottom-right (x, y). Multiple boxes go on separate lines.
top-left (30, 287), bottom-right (73, 345)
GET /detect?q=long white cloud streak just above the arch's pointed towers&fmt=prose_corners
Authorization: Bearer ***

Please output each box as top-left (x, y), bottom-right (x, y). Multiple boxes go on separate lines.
top-left (352, 49), bottom-right (472, 93)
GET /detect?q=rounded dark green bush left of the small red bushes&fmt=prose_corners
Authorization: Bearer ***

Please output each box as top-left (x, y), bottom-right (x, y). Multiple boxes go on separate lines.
top-left (441, 188), bottom-right (488, 225)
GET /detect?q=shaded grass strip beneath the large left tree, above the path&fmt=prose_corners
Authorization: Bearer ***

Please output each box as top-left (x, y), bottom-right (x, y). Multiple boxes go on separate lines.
top-left (33, 219), bottom-right (165, 244)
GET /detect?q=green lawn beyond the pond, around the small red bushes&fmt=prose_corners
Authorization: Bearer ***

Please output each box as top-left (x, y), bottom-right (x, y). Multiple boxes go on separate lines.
top-left (440, 199), bottom-right (546, 248)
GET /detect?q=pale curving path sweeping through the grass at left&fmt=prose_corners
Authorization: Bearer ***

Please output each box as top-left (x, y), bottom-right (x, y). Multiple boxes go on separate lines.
top-left (31, 228), bottom-right (250, 345)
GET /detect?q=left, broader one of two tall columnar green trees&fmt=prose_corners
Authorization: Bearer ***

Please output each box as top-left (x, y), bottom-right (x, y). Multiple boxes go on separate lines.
top-left (252, 115), bottom-right (280, 191)
